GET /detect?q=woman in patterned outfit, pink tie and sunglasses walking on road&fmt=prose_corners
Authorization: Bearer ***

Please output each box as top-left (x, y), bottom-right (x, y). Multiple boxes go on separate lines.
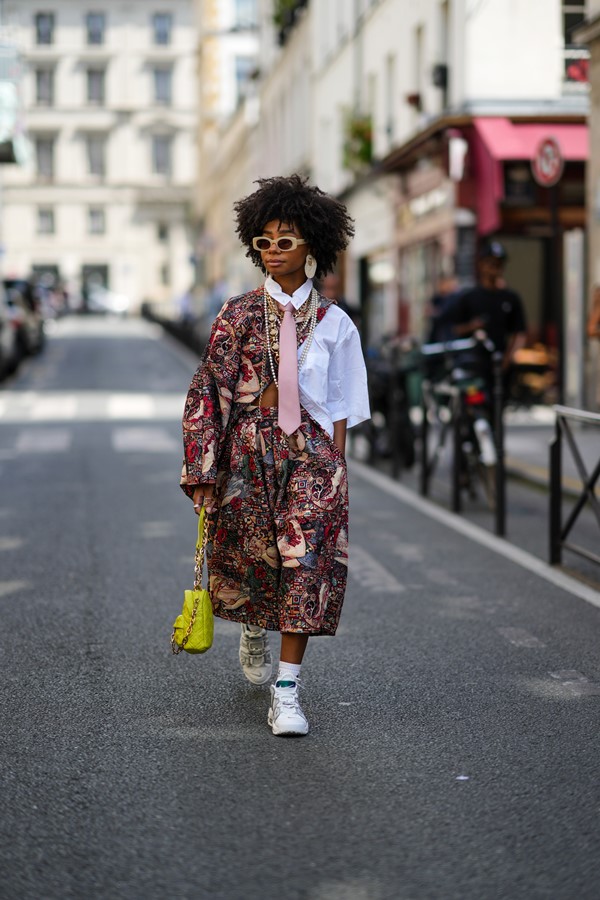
top-left (181, 175), bottom-right (369, 735)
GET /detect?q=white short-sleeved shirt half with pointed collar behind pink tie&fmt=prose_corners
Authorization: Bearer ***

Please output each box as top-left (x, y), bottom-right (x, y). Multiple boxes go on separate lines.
top-left (265, 277), bottom-right (371, 437)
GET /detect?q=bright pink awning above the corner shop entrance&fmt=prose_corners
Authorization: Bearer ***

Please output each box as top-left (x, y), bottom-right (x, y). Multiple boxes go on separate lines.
top-left (471, 117), bottom-right (589, 234)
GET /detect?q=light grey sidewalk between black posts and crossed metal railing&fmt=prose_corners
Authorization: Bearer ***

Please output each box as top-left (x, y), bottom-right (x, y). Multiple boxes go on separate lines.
top-left (505, 406), bottom-right (600, 492)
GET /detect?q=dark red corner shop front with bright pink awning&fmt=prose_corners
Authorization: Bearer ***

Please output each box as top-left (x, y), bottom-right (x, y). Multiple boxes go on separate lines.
top-left (384, 116), bottom-right (589, 396)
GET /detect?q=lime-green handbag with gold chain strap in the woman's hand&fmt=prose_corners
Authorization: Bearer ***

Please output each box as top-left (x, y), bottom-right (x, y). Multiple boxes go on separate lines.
top-left (171, 507), bottom-right (214, 653)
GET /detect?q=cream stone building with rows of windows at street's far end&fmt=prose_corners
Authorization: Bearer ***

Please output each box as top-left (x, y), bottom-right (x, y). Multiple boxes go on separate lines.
top-left (2, 0), bottom-right (196, 308)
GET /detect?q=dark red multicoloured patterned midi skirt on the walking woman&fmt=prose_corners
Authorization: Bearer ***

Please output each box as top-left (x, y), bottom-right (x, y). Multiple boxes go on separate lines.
top-left (207, 404), bottom-right (348, 635)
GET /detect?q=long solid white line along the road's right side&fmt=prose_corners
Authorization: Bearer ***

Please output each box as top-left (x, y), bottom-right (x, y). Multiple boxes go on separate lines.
top-left (348, 460), bottom-right (600, 608)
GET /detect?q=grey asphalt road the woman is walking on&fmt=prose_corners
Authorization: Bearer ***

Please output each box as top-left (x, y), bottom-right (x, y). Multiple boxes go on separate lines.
top-left (0, 319), bottom-right (600, 900)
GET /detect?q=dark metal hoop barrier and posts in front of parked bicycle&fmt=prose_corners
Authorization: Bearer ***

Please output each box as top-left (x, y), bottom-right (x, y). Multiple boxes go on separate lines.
top-left (419, 338), bottom-right (506, 537)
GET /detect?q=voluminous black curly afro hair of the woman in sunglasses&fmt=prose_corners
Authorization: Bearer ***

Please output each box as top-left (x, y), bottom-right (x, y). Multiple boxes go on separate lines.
top-left (233, 175), bottom-right (354, 278)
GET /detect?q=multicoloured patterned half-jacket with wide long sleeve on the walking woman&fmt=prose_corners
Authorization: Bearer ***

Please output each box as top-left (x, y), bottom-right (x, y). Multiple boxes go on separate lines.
top-left (181, 288), bottom-right (332, 497)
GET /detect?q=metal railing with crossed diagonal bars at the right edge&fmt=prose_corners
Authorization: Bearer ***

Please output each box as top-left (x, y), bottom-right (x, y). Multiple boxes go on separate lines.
top-left (549, 406), bottom-right (600, 566)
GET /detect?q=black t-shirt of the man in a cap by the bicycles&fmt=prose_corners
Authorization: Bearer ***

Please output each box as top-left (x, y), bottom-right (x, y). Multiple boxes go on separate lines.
top-left (451, 285), bottom-right (526, 352)
